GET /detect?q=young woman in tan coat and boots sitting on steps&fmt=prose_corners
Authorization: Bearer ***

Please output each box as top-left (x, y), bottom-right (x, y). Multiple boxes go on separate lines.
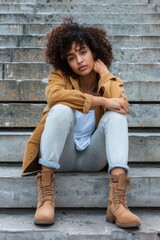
top-left (22, 19), bottom-right (140, 228)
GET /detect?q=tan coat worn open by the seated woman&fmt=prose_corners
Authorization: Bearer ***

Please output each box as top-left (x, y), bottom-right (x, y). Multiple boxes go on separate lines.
top-left (22, 71), bottom-right (124, 175)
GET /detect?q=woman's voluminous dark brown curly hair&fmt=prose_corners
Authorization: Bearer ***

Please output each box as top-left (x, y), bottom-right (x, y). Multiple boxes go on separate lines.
top-left (45, 18), bottom-right (113, 77)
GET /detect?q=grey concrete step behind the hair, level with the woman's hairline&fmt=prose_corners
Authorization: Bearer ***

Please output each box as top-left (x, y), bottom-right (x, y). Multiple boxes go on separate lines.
top-left (0, 34), bottom-right (160, 49)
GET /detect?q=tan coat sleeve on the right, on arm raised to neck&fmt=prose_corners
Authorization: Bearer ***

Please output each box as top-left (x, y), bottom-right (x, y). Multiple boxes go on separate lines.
top-left (98, 73), bottom-right (127, 98)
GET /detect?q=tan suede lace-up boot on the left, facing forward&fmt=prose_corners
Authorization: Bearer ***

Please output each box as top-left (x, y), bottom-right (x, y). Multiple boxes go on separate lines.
top-left (34, 170), bottom-right (55, 224)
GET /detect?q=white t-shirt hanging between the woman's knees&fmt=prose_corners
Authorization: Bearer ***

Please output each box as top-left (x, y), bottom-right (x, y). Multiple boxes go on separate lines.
top-left (74, 110), bottom-right (96, 151)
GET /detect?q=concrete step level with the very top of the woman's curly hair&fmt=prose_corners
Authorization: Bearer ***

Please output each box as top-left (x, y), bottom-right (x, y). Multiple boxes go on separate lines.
top-left (0, 22), bottom-right (160, 36)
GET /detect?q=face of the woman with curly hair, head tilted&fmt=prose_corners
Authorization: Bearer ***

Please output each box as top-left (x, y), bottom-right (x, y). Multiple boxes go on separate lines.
top-left (67, 42), bottom-right (94, 76)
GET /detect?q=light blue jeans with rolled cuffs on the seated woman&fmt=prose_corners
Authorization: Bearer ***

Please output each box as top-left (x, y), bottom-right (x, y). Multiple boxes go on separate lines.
top-left (39, 104), bottom-right (128, 172)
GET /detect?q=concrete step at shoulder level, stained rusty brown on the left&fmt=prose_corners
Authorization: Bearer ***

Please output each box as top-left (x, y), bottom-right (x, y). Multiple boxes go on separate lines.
top-left (0, 78), bottom-right (160, 102)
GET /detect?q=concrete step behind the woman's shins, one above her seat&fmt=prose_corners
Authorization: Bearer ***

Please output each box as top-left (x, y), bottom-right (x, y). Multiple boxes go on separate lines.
top-left (0, 130), bottom-right (160, 163)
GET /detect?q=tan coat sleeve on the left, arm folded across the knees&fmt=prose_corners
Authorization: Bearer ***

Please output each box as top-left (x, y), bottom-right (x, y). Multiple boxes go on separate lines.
top-left (45, 71), bottom-right (92, 113)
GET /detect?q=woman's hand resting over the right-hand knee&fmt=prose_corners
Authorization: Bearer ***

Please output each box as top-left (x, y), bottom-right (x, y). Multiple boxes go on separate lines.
top-left (103, 98), bottom-right (128, 114)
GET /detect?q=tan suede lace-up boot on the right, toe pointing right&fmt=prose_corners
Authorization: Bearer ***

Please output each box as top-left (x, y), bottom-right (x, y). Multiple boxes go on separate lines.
top-left (106, 174), bottom-right (140, 228)
